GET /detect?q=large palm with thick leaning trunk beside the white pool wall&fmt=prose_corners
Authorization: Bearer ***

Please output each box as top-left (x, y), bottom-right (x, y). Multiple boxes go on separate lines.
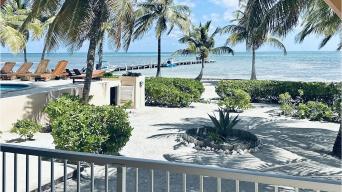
top-left (22, 0), bottom-right (133, 103)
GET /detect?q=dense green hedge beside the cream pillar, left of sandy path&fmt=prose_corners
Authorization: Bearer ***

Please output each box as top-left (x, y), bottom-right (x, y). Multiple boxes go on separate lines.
top-left (145, 78), bottom-right (204, 107)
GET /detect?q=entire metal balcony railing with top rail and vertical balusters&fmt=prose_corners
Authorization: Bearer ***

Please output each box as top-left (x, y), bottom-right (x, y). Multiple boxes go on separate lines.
top-left (0, 144), bottom-right (342, 192)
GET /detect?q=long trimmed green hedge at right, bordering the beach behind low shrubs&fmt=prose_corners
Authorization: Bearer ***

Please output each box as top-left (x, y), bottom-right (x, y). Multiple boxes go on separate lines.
top-left (216, 80), bottom-right (342, 106)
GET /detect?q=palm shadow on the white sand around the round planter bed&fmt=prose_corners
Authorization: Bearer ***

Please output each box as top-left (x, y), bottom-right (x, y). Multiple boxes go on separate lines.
top-left (149, 116), bottom-right (342, 178)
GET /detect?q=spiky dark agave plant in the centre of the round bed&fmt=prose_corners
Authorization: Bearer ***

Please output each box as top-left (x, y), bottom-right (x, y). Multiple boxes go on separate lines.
top-left (208, 109), bottom-right (240, 139)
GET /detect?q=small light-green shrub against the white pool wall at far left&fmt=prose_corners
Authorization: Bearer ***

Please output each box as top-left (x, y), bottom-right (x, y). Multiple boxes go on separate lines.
top-left (12, 119), bottom-right (43, 140)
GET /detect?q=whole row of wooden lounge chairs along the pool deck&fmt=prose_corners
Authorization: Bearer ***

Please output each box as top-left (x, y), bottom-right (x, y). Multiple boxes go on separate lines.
top-left (0, 59), bottom-right (105, 83)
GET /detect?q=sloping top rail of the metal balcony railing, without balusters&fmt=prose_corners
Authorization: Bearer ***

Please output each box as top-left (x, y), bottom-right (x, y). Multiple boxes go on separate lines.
top-left (0, 144), bottom-right (342, 191)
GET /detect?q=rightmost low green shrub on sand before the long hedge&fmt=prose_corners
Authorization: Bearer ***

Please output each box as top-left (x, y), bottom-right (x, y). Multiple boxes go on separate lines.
top-left (306, 101), bottom-right (333, 121)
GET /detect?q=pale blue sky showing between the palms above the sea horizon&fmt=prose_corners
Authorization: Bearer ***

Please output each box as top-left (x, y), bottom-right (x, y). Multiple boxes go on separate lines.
top-left (1, 0), bottom-right (339, 53)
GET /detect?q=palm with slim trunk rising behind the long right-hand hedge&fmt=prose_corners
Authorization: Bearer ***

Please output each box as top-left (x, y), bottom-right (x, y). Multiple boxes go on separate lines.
top-left (221, 11), bottom-right (287, 80)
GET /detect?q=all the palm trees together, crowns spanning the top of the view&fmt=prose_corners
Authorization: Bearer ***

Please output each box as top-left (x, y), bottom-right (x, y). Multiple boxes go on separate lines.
top-left (0, 0), bottom-right (342, 97)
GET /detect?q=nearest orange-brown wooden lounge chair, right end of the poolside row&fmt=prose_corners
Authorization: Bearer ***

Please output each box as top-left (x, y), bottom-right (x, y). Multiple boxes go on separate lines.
top-left (33, 60), bottom-right (69, 81)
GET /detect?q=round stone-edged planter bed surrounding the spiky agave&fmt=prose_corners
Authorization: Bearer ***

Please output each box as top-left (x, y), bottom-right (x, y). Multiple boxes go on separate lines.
top-left (182, 128), bottom-right (260, 154)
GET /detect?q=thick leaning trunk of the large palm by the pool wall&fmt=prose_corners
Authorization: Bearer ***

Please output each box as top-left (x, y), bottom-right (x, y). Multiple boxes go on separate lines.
top-left (82, 35), bottom-right (97, 103)
